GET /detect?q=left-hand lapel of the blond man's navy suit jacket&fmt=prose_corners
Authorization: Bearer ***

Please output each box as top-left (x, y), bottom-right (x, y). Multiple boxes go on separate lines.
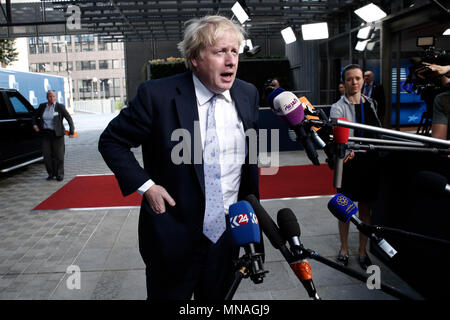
top-left (175, 72), bottom-right (205, 194)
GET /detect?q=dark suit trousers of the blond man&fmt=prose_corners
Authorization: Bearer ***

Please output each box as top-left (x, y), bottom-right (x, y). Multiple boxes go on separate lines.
top-left (146, 224), bottom-right (239, 301)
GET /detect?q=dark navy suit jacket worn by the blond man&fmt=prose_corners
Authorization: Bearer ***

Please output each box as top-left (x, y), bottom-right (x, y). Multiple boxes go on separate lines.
top-left (99, 72), bottom-right (259, 271)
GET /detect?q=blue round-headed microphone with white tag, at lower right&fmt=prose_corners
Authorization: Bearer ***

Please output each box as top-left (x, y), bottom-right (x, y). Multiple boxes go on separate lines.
top-left (328, 193), bottom-right (397, 258)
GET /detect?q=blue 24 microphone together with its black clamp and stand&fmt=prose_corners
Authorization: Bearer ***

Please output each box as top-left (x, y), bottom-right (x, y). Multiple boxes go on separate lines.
top-left (225, 200), bottom-right (268, 300)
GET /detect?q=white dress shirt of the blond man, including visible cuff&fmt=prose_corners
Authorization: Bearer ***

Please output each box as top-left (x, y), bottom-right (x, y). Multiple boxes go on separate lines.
top-left (137, 74), bottom-right (245, 214)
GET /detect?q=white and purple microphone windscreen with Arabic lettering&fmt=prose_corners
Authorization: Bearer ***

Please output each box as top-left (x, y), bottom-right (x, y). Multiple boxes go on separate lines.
top-left (272, 91), bottom-right (305, 127)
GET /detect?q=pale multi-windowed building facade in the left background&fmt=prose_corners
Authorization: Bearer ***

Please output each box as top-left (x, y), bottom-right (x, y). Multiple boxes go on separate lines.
top-left (28, 34), bottom-right (126, 103)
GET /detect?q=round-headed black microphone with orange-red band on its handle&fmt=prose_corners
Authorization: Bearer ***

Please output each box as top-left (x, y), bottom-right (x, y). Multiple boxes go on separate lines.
top-left (277, 208), bottom-right (320, 300)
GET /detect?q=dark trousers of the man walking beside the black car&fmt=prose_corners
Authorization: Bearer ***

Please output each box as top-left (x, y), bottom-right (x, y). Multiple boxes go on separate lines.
top-left (42, 129), bottom-right (65, 177)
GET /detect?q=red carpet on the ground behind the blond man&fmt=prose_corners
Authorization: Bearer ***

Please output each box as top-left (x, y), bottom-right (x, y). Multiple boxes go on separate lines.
top-left (33, 165), bottom-right (336, 210)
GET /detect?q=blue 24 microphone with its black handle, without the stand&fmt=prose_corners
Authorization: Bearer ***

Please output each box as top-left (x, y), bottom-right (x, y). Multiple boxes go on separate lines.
top-left (228, 201), bottom-right (267, 284)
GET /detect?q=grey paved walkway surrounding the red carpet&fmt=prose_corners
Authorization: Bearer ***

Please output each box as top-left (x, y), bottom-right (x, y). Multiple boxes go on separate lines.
top-left (0, 114), bottom-right (418, 300)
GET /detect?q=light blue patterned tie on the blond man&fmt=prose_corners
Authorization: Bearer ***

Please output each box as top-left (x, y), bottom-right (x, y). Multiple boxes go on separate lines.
top-left (203, 95), bottom-right (225, 243)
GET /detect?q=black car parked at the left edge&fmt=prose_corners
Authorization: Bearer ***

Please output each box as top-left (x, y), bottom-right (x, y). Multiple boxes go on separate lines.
top-left (0, 88), bottom-right (42, 172)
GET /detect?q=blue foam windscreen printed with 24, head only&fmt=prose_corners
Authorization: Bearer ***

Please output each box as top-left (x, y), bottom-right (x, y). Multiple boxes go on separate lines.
top-left (228, 201), bottom-right (261, 247)
